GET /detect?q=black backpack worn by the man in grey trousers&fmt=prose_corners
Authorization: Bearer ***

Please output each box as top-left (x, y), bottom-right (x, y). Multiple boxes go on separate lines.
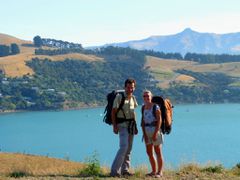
top-left (103, 90), bottom-right (125, 125)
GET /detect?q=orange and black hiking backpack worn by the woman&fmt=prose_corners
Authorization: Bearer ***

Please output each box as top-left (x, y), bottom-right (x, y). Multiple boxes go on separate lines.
top-left (142, 96), bottom-right (173, 134)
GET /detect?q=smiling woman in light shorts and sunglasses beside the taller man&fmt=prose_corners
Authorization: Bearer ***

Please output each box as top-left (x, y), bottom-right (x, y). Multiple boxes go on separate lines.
top-left (141, 91), bottom-right (163, 177)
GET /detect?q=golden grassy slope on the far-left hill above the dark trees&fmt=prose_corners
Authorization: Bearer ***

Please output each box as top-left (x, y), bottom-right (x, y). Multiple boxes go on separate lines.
top-left (0, 34), bottom-right (103, 77)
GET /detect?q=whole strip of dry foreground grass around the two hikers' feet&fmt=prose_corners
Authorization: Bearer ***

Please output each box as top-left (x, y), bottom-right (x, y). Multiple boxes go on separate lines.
top-left (0, 153), bottom-right (240, 180)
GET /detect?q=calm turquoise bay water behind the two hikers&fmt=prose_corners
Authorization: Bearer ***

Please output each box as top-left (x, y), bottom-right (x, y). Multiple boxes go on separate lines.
top-left (0, 104), bottom-right (240, 168)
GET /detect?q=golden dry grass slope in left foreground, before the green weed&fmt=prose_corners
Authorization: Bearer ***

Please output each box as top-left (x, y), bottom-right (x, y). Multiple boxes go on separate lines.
top-left (0, 153), bottom-right (84, 176)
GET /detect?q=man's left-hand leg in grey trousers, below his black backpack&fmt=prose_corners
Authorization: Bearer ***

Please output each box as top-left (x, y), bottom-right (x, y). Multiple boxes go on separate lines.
top-left (111, 127), bottom-right (129, 176)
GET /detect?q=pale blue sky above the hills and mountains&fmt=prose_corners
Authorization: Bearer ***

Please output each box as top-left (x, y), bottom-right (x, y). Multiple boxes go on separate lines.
top-left (0, 0), bottom-right (240, 47)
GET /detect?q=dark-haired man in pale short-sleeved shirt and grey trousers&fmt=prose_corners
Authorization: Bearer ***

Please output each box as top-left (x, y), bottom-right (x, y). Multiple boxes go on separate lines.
top-left (111, 78), bottom-right (138, 177)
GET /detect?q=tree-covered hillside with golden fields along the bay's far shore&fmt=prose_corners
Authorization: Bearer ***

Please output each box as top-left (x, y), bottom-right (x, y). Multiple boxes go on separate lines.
top-left (0, 35), bottom-right (240, 112)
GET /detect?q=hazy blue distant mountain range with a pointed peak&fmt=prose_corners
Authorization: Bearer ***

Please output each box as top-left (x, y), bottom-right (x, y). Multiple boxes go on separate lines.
top-left (104, 28), bottom-right (240, 55)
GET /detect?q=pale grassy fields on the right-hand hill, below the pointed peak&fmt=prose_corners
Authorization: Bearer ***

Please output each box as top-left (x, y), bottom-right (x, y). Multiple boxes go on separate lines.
top-left (145, 56), bottom-right (240, 88)
